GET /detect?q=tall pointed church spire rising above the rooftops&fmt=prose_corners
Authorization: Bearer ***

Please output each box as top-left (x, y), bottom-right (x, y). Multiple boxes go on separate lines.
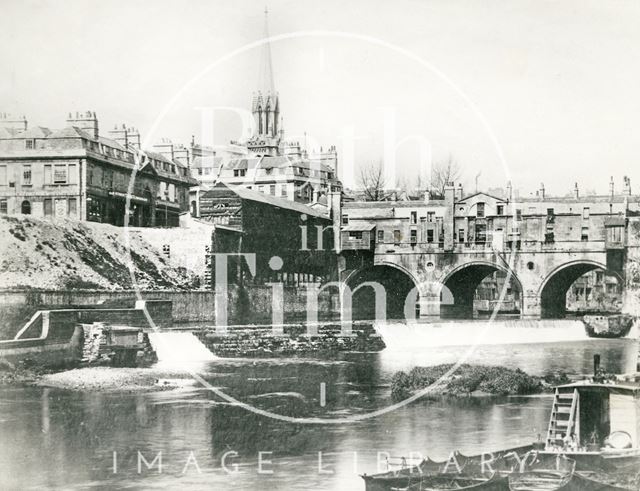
top-left (247, 8), bottom-right (282, 155)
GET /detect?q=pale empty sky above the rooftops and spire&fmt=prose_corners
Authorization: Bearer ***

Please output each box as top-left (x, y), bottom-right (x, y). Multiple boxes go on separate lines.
top-left (0, 0), bottom-right (640, 195)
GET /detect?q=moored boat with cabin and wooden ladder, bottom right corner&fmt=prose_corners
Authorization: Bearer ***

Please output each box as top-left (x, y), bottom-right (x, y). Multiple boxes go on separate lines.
top-left (362, 355), bottom-right (640, 491)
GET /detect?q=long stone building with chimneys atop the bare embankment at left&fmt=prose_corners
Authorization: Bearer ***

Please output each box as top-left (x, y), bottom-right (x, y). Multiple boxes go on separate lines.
top-left (0, 112), bottom-right (197, 227)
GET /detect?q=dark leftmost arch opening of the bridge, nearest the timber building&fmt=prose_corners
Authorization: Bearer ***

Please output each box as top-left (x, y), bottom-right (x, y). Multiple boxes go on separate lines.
top-left (347, 265), bottom-right (416, 320)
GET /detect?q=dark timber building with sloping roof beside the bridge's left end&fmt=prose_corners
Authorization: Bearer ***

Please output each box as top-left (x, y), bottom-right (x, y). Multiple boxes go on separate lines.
top-left (200, 183), bottom-right (336, 285)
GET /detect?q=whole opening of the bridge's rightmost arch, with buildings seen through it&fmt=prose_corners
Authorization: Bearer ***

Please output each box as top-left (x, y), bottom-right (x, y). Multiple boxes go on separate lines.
top-left (540, 261), bottom-right (623, 319)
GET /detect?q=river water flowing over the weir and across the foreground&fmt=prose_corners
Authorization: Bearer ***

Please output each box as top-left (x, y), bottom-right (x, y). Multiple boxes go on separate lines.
top-left (0, 325), bottom-right (638, 490)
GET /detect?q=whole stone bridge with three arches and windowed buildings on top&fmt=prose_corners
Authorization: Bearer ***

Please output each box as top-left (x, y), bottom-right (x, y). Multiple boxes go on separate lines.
top-left (332, 186), bottom-right (640, 319)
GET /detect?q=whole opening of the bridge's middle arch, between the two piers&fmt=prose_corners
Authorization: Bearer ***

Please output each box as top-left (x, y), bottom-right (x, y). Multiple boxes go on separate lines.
top-left (440, 262), bottom-right (522, 319)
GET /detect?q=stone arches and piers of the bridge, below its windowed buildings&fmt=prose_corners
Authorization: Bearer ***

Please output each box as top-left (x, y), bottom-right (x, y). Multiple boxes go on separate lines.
top-left (341, 248), bottom-right (607, 319)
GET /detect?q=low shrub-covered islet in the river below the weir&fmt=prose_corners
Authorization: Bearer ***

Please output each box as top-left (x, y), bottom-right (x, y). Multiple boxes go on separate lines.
top-left (391, 364), bottom-right (566, 401)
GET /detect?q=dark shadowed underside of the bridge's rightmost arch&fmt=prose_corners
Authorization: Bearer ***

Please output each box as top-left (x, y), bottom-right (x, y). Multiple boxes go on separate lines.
top-left (538, 259), bottom-right (621, 319)
